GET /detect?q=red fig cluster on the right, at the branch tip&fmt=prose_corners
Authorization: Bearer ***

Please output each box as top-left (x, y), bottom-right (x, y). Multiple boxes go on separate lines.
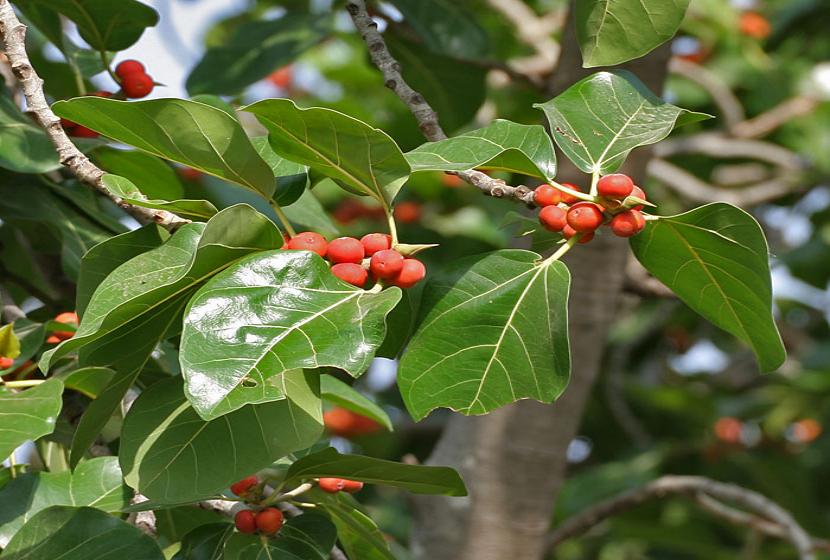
top-left (533, 173), bottom-right (646, 243)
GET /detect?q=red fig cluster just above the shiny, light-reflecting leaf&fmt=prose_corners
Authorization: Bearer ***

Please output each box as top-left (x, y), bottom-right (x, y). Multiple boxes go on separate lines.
top-left (282, 231), bottom-right (427, 288)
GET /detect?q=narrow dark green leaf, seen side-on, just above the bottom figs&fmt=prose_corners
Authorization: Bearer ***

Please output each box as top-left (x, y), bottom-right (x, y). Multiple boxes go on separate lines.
top-left (285, 447), bottom-right (467, 496)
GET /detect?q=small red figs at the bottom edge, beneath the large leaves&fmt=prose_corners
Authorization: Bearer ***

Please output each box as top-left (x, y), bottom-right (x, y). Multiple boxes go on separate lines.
top-left (231, 475), bottom-right (363, 536)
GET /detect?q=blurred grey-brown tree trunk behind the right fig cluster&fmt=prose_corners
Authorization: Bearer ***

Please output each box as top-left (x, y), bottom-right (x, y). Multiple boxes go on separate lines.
top-left (412, 8), bottom-right (669, 560)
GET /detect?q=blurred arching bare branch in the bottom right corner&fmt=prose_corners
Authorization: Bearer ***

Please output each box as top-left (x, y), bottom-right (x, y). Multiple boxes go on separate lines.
top-left (547, 476), bottom-right (816, 560)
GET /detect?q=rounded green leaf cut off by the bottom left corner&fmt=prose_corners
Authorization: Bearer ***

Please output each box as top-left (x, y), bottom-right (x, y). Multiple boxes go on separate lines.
top-left (0, 506), bottom-right (164, 560)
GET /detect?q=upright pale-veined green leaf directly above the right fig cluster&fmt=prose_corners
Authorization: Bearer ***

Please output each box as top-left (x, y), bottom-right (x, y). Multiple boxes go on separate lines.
top-left (534, 70), bottom-right (709, 174)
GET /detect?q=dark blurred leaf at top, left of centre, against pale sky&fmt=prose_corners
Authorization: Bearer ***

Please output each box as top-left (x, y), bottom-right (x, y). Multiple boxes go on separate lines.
top-left (187, 12), bottom-right (330, 95)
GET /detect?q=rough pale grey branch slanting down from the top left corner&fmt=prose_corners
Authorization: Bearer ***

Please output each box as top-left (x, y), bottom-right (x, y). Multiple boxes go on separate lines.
top-left (0, 0), bottom-right (189, 231)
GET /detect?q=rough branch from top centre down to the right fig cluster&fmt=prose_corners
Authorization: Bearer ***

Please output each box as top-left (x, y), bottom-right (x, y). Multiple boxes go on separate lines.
top-left (346, 0), bottom-right (535, 206)
